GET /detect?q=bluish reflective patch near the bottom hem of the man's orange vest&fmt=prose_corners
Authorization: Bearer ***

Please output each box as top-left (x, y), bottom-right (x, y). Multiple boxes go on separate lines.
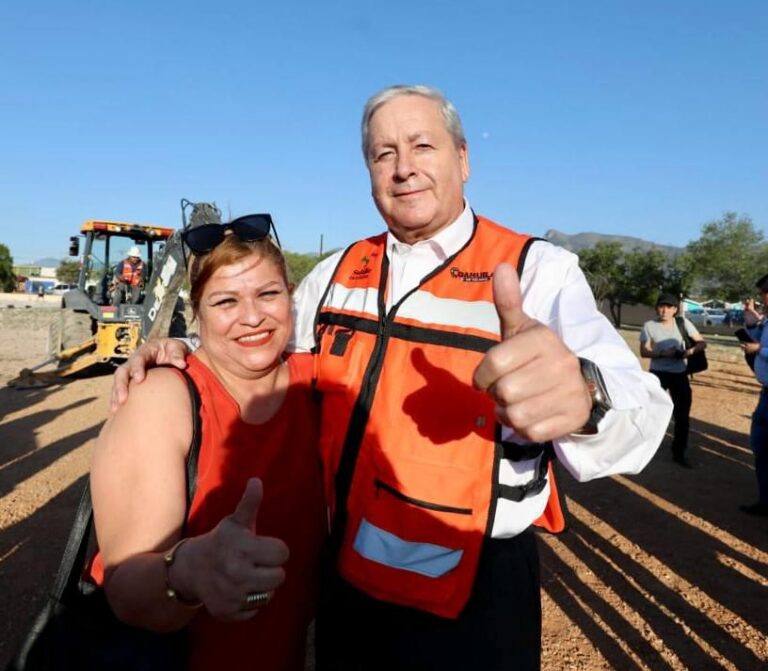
top-left (353, 518), bottom-right (464, 578)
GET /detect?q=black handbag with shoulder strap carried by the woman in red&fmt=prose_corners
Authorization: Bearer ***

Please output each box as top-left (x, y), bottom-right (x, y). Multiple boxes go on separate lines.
top-left (6, 370), bottom-right (201, 671)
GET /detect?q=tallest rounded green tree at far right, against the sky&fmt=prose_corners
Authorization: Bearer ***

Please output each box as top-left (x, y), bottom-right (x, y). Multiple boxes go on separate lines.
top-left (687, 212), bottom-right (768, 301)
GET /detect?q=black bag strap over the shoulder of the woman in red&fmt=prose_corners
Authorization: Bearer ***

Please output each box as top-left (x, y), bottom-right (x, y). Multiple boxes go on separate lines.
top-left (51, 366), bottom-right (202, 601)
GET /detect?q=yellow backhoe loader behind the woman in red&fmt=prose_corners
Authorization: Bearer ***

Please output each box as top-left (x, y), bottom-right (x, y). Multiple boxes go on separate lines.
top-left (8, 199), bottom-right (221, 388)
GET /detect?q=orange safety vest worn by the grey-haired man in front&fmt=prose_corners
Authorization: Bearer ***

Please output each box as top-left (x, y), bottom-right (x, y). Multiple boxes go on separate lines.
top-left (315, 217), bottom-right (564, 618)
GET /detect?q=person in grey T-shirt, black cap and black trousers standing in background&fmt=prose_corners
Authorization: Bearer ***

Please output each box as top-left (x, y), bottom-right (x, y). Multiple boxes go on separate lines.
top-left (640, 293), bottom-right (707, 468)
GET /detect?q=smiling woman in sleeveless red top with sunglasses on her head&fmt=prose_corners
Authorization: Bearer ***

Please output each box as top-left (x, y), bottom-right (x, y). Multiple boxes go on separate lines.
top-left (91, 218), bottom-right (324, 671)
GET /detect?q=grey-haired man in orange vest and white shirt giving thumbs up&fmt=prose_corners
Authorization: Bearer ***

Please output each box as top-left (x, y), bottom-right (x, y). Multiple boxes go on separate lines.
top-left (113, 85), bottom-right (671, 671)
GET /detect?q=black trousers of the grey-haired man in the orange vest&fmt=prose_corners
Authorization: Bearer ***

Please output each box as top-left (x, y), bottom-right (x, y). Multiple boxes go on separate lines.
top-left (316, 530), bottom-right (541, 671)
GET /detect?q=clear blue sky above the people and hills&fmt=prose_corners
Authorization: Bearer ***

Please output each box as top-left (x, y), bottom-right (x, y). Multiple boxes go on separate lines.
top-left (0, 0), bottom-right (768, 262)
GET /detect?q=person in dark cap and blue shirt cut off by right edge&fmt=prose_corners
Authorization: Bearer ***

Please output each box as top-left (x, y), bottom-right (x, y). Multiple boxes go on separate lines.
top-left (739, 275), bottom-right (768, 517)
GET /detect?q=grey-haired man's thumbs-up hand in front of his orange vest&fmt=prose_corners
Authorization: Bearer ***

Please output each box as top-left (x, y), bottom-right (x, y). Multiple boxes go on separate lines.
top-left (474, 263), bottom-right (592, 442)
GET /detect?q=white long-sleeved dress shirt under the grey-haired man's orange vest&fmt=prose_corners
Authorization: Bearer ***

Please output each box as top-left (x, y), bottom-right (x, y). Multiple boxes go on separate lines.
top-left (294, 203), bottom-right (672, 538)
